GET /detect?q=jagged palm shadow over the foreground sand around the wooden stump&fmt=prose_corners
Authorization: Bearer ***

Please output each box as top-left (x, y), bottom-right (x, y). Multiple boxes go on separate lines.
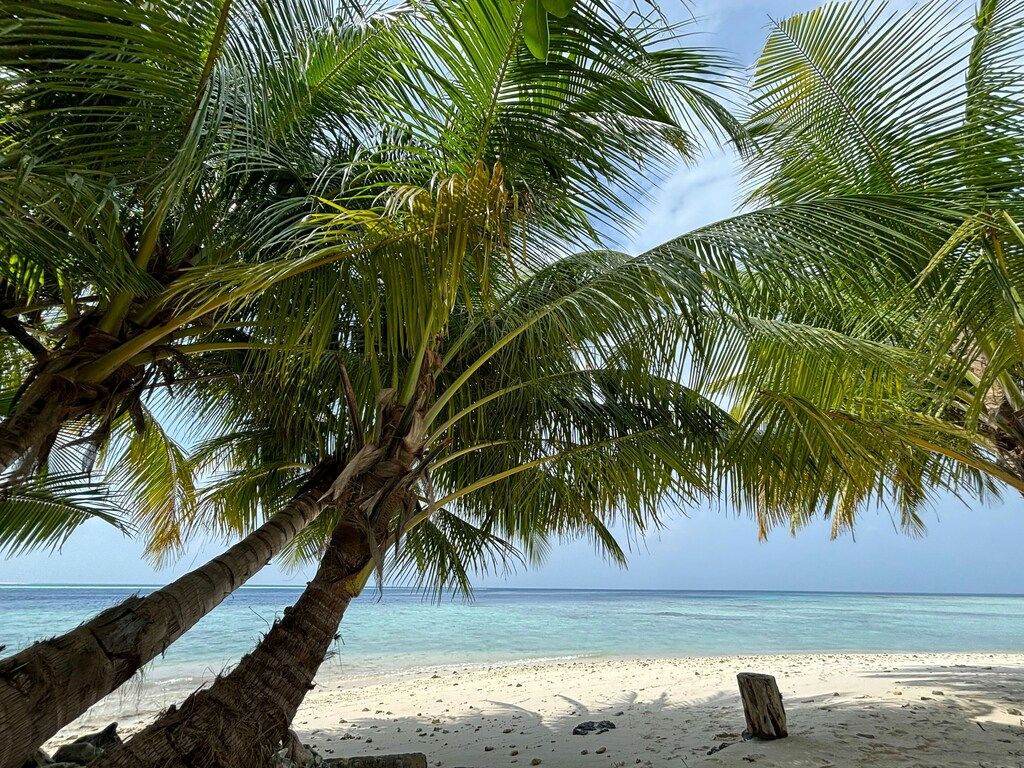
top-left (300, 666), bottom-right (1024, 768)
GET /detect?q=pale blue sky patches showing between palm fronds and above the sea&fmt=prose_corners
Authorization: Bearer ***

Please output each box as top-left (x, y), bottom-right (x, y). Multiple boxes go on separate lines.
top-left (0, 0), bottom-right (1024, 594)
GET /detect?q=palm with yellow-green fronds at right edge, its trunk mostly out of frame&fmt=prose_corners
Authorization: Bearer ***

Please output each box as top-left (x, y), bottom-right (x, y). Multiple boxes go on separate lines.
top-left (643, 0), bottom-right (1024, 535)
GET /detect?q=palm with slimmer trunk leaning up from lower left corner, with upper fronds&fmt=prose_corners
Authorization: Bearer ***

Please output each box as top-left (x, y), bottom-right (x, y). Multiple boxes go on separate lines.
top-left (0, 4), bottom-right (731, 755)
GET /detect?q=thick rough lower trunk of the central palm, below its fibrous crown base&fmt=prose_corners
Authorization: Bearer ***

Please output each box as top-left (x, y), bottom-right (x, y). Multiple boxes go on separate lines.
top-left (92, 523), bottom-right (371, 768)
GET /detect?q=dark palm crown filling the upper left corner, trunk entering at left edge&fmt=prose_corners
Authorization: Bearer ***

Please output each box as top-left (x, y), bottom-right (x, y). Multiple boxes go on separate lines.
top-left (0, 0), bottom-right (417, 483)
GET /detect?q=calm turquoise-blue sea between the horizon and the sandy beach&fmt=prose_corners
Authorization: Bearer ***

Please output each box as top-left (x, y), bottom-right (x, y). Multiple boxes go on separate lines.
top-left (0, 586), bottom-right (1024, 680)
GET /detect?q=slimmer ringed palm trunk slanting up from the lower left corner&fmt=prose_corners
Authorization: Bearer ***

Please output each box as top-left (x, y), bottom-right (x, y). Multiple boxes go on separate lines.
top-left (0, 462), bottom-right (336, 768)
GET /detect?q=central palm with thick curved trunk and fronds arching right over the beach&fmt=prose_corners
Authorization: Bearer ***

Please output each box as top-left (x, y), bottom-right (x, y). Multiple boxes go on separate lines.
top-left (101, 3), bottom-right (1024, 766)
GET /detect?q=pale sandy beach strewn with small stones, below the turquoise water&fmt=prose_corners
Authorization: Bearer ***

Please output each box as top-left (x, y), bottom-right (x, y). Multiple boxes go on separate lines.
top-left (49, 653), bottom-right (1024, 768)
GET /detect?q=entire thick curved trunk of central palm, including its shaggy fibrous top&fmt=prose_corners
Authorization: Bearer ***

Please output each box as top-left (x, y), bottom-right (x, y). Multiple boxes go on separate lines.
top-left (92, 370), bottom-right (439, 768)
